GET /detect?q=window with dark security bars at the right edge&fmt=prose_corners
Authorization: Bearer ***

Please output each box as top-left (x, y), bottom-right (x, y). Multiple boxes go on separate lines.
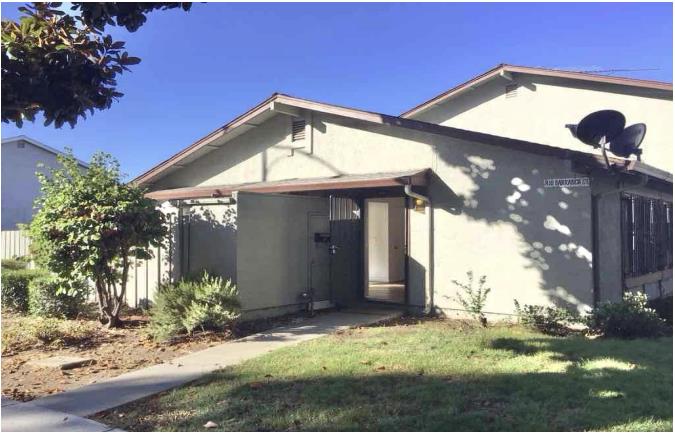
top-left (621, 194), bottom-right (673, 278)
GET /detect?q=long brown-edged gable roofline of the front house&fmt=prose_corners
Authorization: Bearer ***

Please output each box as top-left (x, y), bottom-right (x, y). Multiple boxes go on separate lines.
top-left (132, 93), bottom-right (672, 185)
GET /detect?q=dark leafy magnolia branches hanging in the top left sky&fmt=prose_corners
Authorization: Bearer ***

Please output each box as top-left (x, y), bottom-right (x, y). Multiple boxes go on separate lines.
top-left (0, 2), bottom-right (191, 128)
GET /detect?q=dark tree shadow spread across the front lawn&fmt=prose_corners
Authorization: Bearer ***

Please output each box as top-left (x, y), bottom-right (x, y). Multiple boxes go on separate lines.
top-left (119, 338), bottom-right (672, 431)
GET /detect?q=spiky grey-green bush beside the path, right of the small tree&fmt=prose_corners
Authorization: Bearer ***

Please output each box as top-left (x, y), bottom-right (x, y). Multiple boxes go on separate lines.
top-left (149, 272), bottom-right (240, 340)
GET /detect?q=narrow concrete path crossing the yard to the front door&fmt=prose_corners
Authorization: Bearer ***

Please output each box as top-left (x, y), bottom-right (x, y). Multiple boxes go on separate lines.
top-left (29, 308), bottom-right (401, 416)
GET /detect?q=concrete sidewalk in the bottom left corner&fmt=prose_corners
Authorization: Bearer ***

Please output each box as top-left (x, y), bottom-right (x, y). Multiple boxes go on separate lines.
top-left (2, 396), bottom-right (123, 432)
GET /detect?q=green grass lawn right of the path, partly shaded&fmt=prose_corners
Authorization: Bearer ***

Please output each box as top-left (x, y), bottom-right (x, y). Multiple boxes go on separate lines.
top-left (101, 321), bottom-right (673, 431)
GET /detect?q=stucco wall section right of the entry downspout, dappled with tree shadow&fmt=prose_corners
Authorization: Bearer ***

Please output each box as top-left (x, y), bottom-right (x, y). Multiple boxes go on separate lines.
top-left (431, 137), bottom-right (593, 313)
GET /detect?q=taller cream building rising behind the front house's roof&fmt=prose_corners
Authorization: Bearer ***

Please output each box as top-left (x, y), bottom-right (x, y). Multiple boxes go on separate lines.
top-left (401, 64), bottom-right (673, 173)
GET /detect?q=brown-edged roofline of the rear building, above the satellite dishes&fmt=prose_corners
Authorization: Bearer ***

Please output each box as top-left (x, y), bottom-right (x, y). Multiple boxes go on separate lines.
top-left (401, 63), bottom-right (673, 117)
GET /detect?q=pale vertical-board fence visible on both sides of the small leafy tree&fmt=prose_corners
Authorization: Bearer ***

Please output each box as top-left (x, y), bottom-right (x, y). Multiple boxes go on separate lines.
top-left (0, 230), bottom-right (173, 308)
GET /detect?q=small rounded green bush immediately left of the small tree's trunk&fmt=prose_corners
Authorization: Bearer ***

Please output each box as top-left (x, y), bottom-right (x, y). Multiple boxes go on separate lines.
top-left (28, 275), bottom-right (87, 319)
